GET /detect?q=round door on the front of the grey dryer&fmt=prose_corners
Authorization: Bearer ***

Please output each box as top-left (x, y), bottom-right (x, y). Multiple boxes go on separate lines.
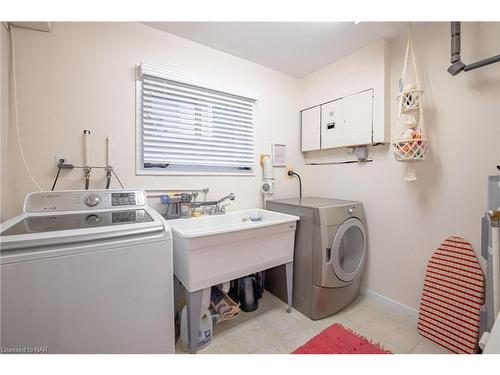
top-left (331, 218), bottom-right (366, 282)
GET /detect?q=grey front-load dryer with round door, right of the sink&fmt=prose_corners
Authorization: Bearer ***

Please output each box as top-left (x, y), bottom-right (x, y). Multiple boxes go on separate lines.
top-left (266, 197), bottom-right (367, 320)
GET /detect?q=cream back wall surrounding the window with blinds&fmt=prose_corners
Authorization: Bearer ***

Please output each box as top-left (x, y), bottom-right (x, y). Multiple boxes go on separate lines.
top-left (2, 23), bottom-right (303, 217)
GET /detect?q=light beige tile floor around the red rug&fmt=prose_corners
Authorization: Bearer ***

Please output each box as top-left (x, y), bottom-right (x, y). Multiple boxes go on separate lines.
top-left (176, 291), bottom-right (450, 354)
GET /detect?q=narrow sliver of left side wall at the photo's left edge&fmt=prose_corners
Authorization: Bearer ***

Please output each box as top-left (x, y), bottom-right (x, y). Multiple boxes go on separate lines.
top-left (0, 25), bottom-right (13, 222)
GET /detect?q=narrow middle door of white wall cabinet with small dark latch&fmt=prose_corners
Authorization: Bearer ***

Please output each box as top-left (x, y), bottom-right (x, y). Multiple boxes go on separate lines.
top-left (321, 99), bottom-right (344, 149)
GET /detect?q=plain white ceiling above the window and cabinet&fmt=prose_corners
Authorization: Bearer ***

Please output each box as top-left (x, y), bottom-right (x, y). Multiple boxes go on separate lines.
top-left (145, 22), bottom-right (408, 78)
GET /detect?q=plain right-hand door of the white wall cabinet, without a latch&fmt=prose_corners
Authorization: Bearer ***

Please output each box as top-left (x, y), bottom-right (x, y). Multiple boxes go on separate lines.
top-left (342, 89), bottom-right (373, 146)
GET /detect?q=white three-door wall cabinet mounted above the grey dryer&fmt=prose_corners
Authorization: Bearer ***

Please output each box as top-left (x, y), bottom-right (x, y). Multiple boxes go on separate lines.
top-left (302, 89), bottom-right (374, 152)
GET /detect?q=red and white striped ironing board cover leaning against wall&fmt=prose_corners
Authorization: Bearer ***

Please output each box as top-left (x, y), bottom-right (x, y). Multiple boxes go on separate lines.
top-left (417, 237), bottom-right (484, 353)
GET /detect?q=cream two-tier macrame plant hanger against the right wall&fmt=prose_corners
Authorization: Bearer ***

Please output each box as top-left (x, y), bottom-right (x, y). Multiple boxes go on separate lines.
top-left (392, 25), bottom-right (428, 181)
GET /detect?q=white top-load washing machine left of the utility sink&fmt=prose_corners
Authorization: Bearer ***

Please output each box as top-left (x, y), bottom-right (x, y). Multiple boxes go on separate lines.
top-left (0, 190), bottom-right (175, 353)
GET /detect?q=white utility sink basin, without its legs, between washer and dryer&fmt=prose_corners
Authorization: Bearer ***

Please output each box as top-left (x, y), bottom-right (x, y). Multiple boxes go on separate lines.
top-left (168, 209), bottom-right (300, 292)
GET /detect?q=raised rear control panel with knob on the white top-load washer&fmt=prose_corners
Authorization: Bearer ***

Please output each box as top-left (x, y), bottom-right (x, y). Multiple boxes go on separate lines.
top-left (24, 190), bottom-right (146, 213)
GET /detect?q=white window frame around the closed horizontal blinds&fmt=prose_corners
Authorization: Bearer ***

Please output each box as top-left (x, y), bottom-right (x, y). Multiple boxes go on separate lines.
top-left (135, 62), bottom-right (258, 177)
